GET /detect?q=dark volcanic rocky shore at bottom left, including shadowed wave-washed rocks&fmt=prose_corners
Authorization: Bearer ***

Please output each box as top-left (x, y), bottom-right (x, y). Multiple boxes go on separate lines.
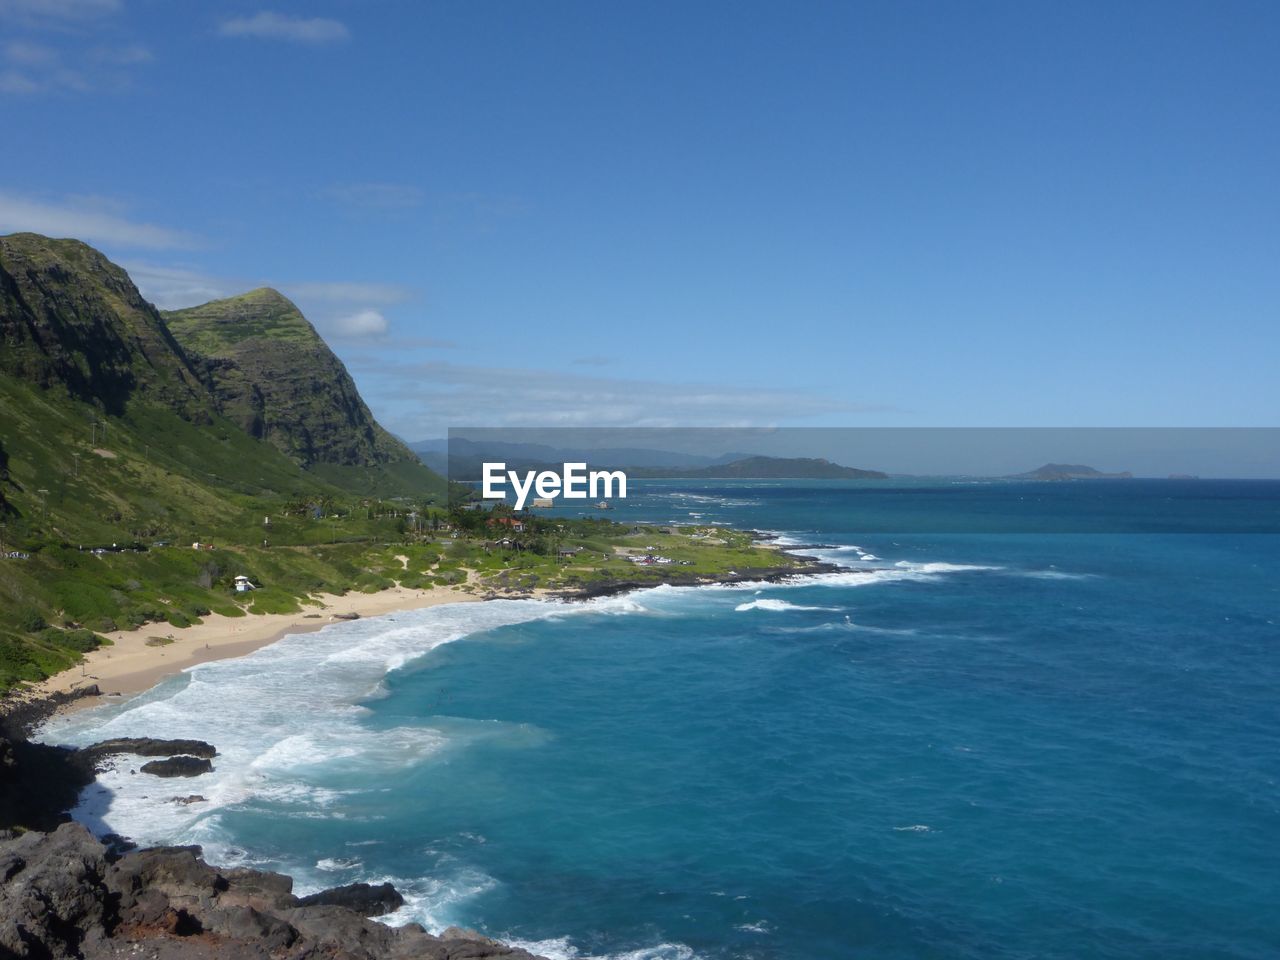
top-left (0, 699), bottom-right (538, 960)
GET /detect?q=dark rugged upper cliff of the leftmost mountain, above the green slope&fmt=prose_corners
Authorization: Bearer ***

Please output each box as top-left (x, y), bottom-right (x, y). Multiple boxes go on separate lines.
top-left (0, 233), bottom-right (209, 419)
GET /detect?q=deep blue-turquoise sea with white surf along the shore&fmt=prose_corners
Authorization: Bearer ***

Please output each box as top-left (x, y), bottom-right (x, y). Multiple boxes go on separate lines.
top-left (46, 480), bottom-right (1280, 960)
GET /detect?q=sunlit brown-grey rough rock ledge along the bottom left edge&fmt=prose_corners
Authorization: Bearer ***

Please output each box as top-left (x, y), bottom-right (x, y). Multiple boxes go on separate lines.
top-left (0, 823), bottom-right (536, 960)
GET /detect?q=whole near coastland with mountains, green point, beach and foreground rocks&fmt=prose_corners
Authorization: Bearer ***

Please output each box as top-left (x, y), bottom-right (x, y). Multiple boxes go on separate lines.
top-left (0, 234), bottom-right (827, 960)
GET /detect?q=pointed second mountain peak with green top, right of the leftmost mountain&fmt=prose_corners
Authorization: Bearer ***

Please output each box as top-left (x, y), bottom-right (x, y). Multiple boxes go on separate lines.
top-left (164, 288), bottom-right (416, 467)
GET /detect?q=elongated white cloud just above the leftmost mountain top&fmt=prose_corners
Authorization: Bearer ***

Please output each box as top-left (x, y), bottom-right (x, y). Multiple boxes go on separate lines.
top-left (0, 192), bottom-right (200, 250)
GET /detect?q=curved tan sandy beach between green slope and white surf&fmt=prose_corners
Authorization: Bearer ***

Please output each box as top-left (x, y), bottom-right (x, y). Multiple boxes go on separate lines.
top-left (31, 586), bottom-right (481, 707)
